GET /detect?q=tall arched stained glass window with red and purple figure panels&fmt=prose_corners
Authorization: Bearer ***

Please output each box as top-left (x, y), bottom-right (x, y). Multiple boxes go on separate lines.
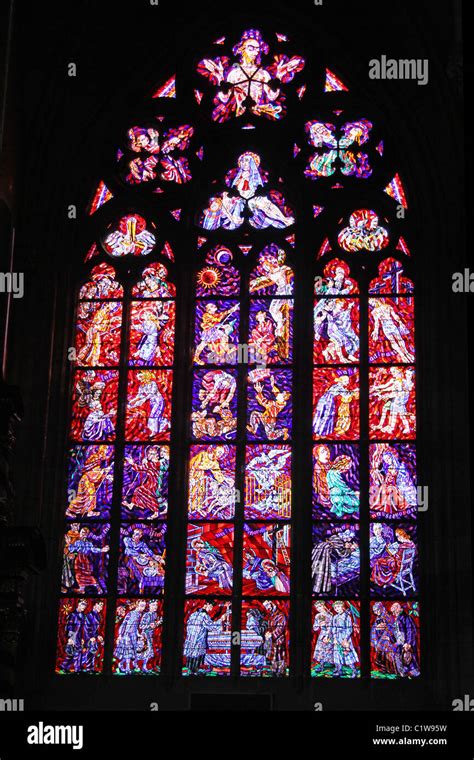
top-left (56, 27), bottom-right (420, 688)
